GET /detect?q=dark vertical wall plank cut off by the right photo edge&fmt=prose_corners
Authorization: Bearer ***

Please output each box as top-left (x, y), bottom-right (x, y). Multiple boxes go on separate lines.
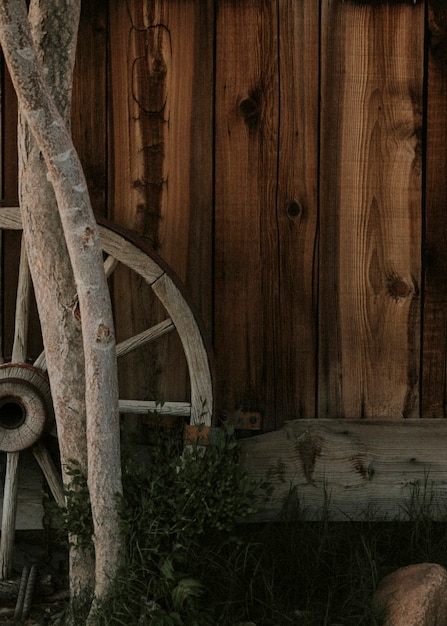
top-left (422, 0), bottom-right (447, 417)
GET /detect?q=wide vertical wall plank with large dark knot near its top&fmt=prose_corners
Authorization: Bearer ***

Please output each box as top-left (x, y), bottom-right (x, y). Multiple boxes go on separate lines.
top-left (215, 0), bottom-right (279, 429)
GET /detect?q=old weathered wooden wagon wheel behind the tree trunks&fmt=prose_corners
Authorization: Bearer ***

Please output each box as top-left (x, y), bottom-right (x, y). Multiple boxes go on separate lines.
top-left (0, 207), bottom-right (213, 580)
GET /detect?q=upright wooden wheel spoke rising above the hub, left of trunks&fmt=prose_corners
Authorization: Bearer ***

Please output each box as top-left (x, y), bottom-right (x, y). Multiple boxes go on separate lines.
top-left (12, 237), bottom-right (31, 363)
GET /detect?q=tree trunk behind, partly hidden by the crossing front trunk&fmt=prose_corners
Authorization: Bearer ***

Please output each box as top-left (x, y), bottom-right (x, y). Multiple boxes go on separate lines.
top-left (18, 0), bottom-right (94, 599)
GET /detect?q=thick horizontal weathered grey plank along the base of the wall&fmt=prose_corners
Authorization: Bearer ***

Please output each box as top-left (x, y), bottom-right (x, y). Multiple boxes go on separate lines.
top-left (241, 419), bottom-right (447, 521)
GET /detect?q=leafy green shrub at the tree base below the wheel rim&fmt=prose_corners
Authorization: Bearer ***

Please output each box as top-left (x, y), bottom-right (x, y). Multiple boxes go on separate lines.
top-left (90, 425), bottom-right (267, 626)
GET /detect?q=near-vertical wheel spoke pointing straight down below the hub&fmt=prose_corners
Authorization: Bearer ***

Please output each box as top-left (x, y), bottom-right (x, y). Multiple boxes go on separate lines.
top-left (0, 452), bottom-right (20, 580)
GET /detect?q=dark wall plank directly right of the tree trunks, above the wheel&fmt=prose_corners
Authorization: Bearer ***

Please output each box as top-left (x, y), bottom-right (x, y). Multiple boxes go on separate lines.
top-left (72, 0), bottom-right (107, 217)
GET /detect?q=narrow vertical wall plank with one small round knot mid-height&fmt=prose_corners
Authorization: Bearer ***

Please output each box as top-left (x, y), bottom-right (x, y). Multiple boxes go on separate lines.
top-left (276, 0), bottom-right (319, 420)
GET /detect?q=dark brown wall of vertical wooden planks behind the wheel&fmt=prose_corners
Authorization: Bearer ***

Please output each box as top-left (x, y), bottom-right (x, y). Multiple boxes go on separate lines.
top-left (3, 0), bottom-right (447, 430)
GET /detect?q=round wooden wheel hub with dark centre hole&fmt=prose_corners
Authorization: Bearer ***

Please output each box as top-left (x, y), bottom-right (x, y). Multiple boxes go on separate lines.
top-left (0, 363), bottom-right (53, 452)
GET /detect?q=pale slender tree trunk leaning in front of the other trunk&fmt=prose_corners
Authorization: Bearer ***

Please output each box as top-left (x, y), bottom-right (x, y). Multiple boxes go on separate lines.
top-left (0, 0), bottom-right (121, 608)
